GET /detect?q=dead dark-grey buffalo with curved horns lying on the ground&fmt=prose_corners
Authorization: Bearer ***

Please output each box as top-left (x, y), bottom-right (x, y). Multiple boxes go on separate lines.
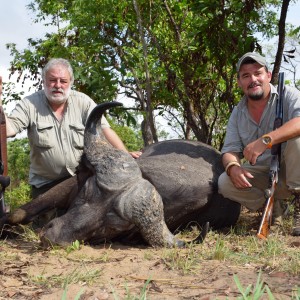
top-left (2, 102), bottom-right (240, 246)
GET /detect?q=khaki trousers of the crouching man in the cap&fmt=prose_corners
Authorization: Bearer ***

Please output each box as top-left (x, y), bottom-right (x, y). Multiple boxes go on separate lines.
top-left (218, 137), bottom-right (300, 211)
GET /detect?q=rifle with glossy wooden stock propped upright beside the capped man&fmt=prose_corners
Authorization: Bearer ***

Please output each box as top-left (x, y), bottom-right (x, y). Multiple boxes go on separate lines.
top-left (257, 72), bottom-right (284, 240)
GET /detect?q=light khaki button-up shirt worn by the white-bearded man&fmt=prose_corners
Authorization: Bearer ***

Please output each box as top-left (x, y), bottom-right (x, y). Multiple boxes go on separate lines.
top-left (8, 91), bottom-right (109, 188)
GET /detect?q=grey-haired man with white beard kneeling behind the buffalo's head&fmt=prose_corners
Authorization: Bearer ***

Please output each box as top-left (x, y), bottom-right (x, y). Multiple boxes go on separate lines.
top-left (7, 58), bottom-right (140, 198)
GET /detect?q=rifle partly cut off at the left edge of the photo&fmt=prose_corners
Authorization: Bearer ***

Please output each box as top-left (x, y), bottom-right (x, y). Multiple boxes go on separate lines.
top-left (0, 76), bottom-right (10, 218)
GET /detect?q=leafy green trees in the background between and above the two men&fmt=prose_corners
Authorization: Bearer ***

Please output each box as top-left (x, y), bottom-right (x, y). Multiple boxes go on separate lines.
top-left (4, 0), bottom-right (286, 145)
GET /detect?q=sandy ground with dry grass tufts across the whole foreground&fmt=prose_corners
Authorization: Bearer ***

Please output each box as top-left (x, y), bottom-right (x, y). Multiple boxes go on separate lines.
top-left (0, 211), bottom-right (300, 300)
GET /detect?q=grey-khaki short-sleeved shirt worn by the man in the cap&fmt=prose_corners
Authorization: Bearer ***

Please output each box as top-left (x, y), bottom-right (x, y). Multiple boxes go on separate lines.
top-left (222, 84), bottom-right (300, 165)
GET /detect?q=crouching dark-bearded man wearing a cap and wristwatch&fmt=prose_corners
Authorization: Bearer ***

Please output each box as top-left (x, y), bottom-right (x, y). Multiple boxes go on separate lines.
top-left (219, 52), bottom-right (300, 236)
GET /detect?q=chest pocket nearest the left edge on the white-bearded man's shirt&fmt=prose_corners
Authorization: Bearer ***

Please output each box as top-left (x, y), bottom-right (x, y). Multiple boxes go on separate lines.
top-left (33, 122), bottom-right (56, 148)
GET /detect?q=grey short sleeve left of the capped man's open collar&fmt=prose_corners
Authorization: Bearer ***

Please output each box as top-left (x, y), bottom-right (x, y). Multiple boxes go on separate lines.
top-left (221, 107), bottom-right (243, 154)
